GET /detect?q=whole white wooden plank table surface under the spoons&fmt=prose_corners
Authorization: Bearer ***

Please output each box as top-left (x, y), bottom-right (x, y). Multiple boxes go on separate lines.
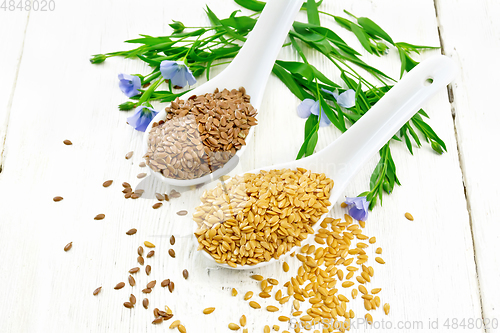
top-left (0, 0), bottom-right (500, 333)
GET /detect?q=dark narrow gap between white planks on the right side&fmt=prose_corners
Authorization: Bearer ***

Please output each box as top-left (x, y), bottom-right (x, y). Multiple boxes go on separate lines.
top-left (434, 0), bottom-right (488, 333)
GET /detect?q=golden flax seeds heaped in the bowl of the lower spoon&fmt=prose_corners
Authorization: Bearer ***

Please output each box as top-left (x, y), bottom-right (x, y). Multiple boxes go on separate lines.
top-left (193, 168), bottom-right (333, 267)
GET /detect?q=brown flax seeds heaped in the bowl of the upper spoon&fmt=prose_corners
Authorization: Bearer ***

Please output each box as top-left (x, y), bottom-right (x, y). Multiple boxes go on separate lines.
top-left (144, 88), bottom-right (257, 179)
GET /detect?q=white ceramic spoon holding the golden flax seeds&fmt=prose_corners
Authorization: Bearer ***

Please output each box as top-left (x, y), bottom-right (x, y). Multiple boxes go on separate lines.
top-left (195, 55), bottom-right (456, 269)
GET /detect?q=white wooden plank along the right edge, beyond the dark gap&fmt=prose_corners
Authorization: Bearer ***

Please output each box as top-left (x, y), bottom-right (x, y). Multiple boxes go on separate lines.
top-left (436, 0), bottom-right (500, 326)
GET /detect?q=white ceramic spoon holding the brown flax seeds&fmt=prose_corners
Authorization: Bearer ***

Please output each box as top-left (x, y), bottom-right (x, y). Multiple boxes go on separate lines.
top-left (143, 0), bottom-right (304, 186)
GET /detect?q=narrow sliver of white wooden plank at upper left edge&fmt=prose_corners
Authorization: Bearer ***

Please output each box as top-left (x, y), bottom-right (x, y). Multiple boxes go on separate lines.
top-left (0, 9), bottom-right (29, 171)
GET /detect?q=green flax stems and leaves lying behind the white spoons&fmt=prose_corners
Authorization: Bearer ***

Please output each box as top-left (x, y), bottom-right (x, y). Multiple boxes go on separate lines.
top-left (90, 0), bottom-right (446, 209)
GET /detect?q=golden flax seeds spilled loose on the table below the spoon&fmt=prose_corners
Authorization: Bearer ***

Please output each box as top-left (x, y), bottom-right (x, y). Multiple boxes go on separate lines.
top-left (199, 214), bottom-right (390, 333)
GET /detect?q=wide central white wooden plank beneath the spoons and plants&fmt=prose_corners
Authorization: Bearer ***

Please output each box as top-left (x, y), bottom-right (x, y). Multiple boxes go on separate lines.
top-left (0, 0), bottom-right (482, 332)
